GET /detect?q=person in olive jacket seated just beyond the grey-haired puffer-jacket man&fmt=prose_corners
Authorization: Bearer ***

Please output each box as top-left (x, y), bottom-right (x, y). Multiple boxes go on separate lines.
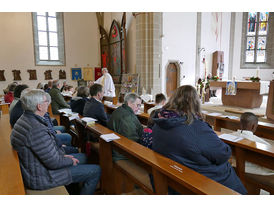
top-left (49, 80), bottom-right (70, 114)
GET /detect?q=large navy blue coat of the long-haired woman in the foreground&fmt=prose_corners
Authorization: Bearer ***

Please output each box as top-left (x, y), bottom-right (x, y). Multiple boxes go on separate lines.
top-left (152, 117), bottom-right (247, 194)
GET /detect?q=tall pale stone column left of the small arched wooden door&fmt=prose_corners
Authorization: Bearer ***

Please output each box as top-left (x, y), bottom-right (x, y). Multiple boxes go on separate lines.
top-left (136, 12), bottom-right (162, 95)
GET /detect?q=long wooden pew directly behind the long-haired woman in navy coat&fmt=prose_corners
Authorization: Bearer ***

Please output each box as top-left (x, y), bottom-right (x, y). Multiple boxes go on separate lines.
top-left (76, 120), bottom-right (238, 195)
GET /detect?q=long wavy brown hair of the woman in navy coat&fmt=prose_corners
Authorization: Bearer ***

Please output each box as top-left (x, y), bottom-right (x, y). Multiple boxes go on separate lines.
top-left (164, 85), bottom-right (202, 124)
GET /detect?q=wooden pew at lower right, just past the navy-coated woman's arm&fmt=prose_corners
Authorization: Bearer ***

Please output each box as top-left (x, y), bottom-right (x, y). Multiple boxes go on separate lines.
top-left (216, 132), bottom-right (274, 194)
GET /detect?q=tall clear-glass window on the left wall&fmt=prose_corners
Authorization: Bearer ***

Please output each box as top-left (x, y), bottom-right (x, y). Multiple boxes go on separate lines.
top-left (32, 12), bottom-right (65, 65)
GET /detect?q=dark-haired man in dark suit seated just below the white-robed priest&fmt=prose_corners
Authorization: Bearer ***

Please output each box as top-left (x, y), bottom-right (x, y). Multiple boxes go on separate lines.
top-left (83, 83), bottom-right (108, 126)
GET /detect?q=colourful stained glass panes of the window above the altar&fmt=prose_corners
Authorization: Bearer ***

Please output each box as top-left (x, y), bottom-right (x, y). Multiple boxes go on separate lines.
top-left (245, 12), bottom-right (269, 63)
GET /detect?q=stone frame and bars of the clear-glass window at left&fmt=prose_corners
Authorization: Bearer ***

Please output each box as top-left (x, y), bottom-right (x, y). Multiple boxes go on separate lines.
top-left (32, 12), bottom-right (66, 66)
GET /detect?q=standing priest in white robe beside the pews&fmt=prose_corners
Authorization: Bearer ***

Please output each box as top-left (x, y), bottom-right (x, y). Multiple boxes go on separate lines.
top-left (95, 68), bottom-right (115, 97)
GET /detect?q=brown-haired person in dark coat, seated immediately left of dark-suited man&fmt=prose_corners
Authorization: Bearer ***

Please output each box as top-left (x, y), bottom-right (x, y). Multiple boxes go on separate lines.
top-left (70, 86), bottom-right (89, 116)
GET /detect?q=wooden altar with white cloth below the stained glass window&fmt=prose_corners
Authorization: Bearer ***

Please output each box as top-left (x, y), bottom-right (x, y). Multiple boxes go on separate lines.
top-left (209, 81), bottom-right (269, 108)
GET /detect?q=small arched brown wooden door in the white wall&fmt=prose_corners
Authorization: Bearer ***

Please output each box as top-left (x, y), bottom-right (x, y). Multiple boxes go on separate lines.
top-left (166, 63), bottom-right (179, 97)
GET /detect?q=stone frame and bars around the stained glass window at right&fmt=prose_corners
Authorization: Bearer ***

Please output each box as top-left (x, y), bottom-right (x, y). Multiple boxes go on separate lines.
top-left (240, 12), bottom-right (274, 69)
